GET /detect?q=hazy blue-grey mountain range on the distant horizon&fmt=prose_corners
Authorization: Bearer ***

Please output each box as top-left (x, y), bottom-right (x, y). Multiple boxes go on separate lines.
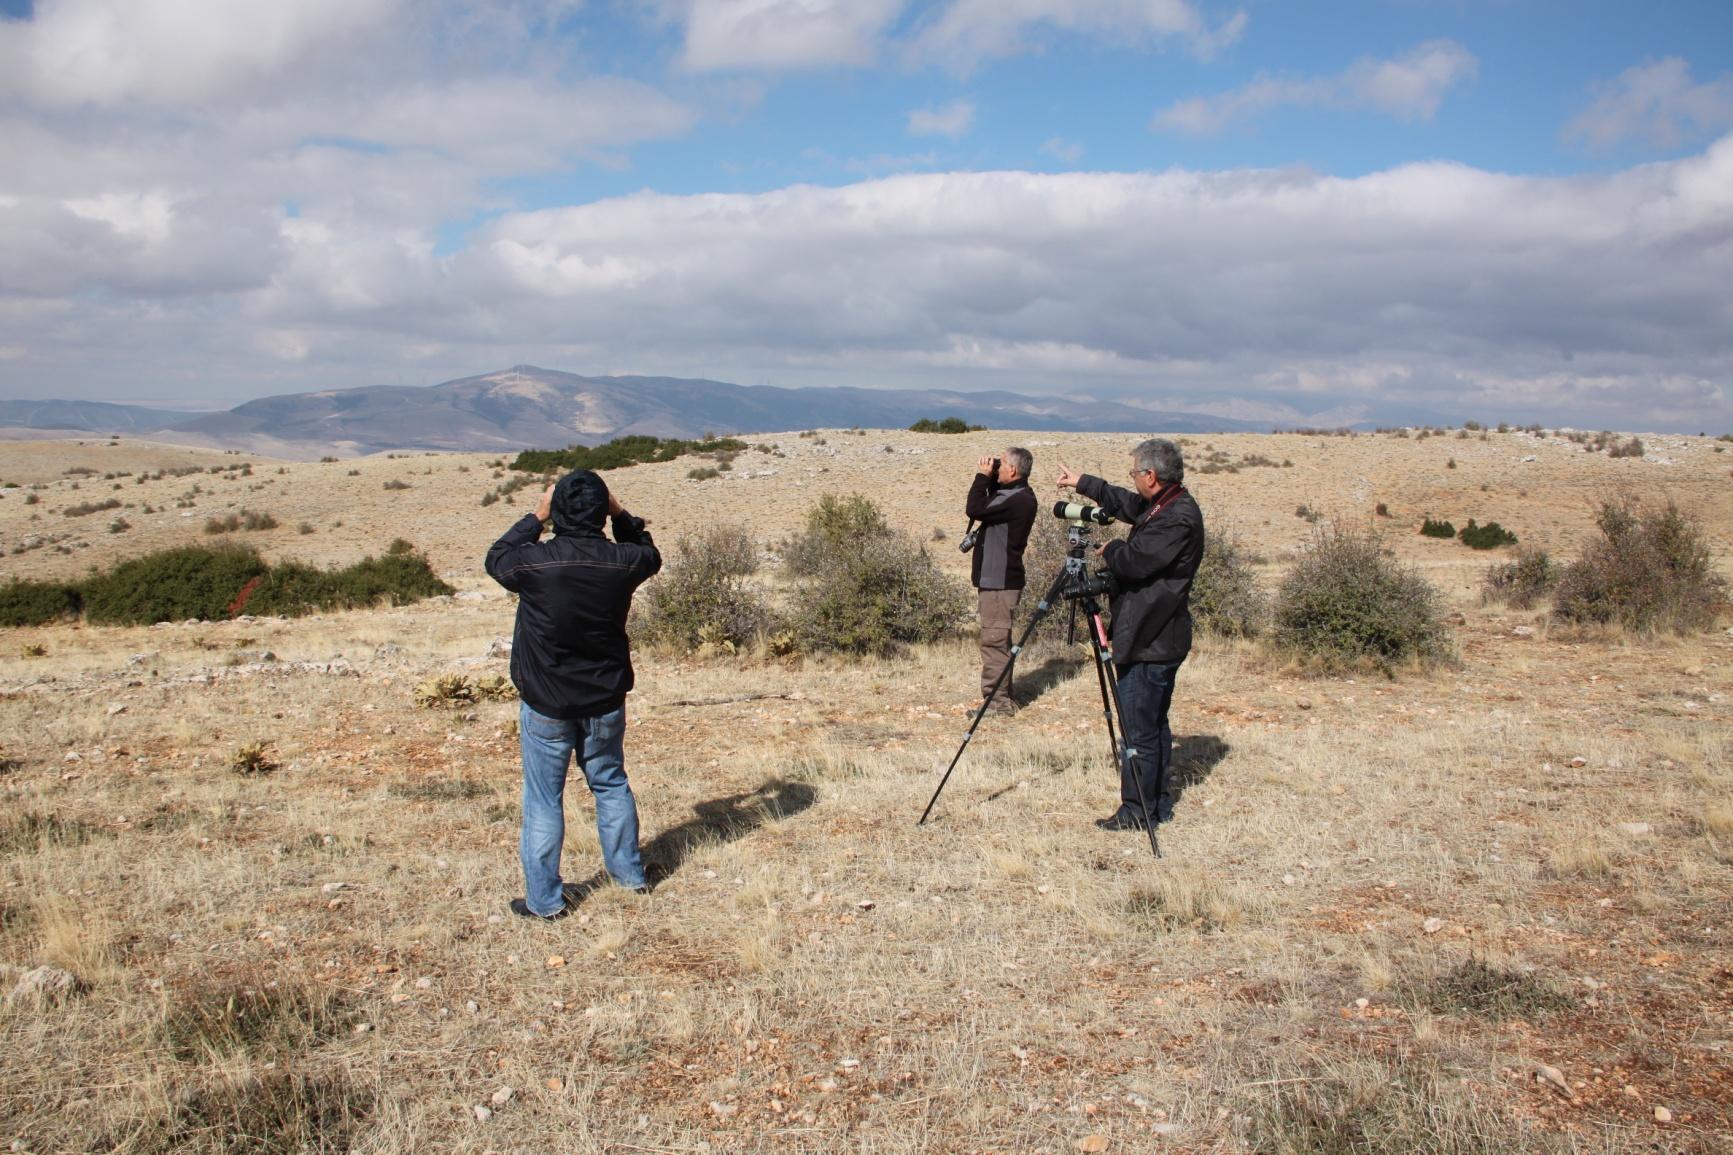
top-left (0, 364), bottom-right (1270, 456)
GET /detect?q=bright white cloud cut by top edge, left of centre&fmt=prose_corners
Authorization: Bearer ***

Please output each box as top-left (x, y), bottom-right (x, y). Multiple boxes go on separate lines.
top-left (664, 0), bottom-right (908, 71)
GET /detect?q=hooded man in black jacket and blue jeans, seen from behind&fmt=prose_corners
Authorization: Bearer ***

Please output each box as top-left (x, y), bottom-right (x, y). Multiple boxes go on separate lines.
top-left (487, 470), bottom-right (662, 919)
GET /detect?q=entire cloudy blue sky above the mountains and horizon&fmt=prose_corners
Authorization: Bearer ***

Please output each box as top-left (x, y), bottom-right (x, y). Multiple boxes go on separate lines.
top-left (0, 0), bottom-right (1733, 430)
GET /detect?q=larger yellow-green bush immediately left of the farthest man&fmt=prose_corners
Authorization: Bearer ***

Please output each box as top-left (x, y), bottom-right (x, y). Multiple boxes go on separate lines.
top-left (783, 494), bottom-right (970, 654)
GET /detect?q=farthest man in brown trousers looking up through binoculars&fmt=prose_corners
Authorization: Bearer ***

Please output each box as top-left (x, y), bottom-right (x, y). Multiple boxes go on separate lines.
top-left (964, 446), bottom-right (1035, 713)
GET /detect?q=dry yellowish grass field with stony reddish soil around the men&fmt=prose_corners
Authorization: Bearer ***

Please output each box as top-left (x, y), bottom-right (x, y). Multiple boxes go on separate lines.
top-left (0, 430), bottom-right (1733, 1155)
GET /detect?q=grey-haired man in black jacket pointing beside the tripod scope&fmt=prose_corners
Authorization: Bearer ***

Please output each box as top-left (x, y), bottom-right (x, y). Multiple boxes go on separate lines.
top-left (1059, 439), bottom-right (1204, 831)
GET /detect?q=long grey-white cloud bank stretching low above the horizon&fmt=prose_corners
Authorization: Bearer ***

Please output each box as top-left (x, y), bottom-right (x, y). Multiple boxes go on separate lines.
top-left (10, 137), bottom-right (1733, 428)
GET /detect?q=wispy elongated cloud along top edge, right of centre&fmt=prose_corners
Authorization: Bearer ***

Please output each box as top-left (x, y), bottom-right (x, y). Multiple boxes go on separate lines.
top-left (910, 0), bottom-right (1246, 71)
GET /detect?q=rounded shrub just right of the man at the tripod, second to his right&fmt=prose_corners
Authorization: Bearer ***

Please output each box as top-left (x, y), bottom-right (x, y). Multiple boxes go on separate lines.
top-left (1275, 525), bottom-right (1449, 673)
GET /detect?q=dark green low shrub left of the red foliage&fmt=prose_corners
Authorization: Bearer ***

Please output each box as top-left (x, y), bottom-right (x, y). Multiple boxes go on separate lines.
top-left (83, 545), bottom-right (267, 626)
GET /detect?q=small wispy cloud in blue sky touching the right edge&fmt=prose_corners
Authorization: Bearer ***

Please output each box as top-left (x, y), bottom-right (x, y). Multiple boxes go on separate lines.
top-left (1565, 57), bottom-right (1733, 149)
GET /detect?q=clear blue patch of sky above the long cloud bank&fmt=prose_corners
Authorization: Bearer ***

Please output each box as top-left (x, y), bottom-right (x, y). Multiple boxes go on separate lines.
top-left (525, 0), bottom-right (1733, 205)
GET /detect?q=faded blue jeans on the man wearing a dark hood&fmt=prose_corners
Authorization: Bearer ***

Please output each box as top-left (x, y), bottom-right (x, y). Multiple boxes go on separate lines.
top-left (518, 702), bottom-right (645, 914)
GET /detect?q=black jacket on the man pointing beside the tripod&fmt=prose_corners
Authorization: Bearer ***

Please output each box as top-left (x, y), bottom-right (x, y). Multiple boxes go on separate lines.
top-left (1078, 475), bottom-right (1203, 666)
